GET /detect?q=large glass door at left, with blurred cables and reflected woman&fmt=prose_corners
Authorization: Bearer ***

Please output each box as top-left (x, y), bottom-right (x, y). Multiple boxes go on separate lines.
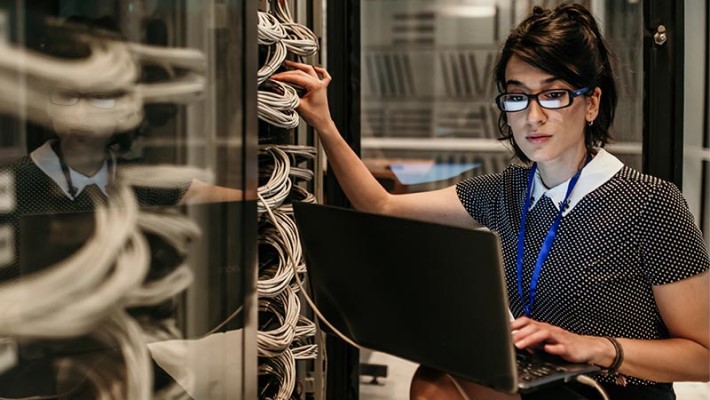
top-left (0, 0), bottom-right (256, 399)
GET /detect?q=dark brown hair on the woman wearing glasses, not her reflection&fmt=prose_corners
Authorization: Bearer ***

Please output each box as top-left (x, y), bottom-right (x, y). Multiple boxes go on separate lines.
top-left (494, 4), bottom-right (617, 162)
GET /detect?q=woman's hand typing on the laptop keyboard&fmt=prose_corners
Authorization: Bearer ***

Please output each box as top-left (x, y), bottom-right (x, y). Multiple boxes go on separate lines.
top-left (510, 317), bottom-right (615, 367)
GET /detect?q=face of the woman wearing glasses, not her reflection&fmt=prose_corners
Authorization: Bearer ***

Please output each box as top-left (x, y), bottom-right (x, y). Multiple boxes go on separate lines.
top-left (505, 56), bottom-right (601, 165)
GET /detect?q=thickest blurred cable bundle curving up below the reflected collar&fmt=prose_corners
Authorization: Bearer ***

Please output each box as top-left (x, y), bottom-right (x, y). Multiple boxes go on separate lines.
top-left (0, 188), bottom-right (148, 338)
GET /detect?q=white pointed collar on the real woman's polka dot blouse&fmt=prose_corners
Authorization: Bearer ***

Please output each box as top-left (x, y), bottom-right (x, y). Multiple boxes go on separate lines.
top-left (530, 149), bottom-right (624, 215)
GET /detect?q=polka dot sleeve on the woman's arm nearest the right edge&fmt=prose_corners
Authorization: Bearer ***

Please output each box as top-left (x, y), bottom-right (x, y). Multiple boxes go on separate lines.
top-left (639, 182), bottom-right (710, 285)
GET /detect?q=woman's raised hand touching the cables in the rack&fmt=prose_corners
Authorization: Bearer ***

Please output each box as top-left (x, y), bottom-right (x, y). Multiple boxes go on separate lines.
top-left (271, 60), bottom-right (333, 131)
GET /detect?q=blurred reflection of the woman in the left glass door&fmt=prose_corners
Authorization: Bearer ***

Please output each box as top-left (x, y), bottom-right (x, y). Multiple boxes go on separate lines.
top-left (0, 28), bottom-right (235, 280)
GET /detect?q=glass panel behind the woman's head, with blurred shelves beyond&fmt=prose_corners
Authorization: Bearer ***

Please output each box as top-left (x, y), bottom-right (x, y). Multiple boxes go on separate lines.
top-left (361, 0), bottom-right (643, 193)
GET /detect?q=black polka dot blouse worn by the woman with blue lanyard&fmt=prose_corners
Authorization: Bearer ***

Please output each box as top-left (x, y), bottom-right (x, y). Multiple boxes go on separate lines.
top-left (456, 153), bottom-right (710, 384)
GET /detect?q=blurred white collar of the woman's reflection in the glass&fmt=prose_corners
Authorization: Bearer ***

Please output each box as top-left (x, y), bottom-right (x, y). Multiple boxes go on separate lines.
top-left (30, 139), bottom-right (115, 199)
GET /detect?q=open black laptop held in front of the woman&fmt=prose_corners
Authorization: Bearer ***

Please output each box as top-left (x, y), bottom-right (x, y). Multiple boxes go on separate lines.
top-left (294, 203), bottom-right (599, 393)
